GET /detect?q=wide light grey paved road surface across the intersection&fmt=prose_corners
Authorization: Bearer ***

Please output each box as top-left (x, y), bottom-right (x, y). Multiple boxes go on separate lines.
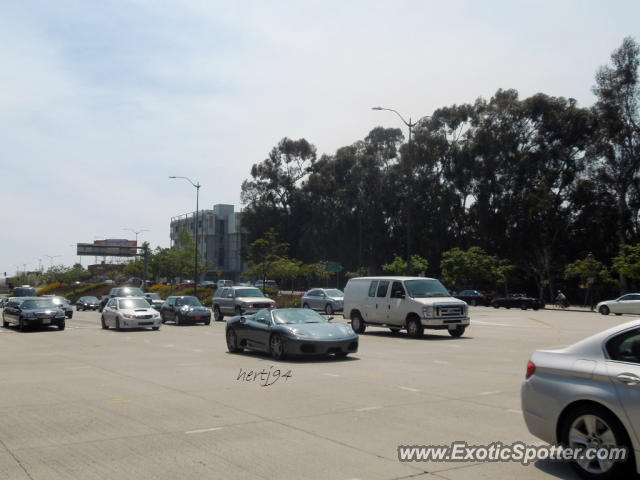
top-left (0, 307), bottom-right (633, 480)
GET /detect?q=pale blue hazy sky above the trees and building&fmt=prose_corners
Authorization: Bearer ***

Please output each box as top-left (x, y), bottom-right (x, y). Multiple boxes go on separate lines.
top-left (0, 0), bottom-right (640, 275)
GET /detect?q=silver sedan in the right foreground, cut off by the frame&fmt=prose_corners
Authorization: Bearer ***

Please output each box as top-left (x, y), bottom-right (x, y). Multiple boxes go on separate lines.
top-left (521, 320), bottom-right (640, 479)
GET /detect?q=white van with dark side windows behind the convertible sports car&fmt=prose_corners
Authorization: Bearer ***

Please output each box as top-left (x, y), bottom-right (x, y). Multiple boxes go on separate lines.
top-left (343, 277), bottom-right (470, 338)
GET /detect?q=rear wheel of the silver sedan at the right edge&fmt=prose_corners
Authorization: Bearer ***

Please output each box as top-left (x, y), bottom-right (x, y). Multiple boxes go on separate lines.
top-left (562, 405), bottom-right (633, 479)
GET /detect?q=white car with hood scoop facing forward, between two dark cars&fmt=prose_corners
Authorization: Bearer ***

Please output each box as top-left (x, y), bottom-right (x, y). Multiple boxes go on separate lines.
top-left (101, 297), bottom-right (162, 330)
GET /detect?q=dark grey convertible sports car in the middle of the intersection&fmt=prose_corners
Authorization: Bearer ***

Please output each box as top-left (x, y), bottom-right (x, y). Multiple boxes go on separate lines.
top-left (226, 308), bottom-right (358, 360)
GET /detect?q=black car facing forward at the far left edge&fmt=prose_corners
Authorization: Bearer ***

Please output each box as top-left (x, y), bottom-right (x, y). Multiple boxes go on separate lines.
top-left (2, 297), bottom-right (65, 330)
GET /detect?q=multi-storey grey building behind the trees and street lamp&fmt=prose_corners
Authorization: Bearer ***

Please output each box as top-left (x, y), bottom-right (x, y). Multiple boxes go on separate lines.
top-left (170, 205), bottom-right (247, 281)
